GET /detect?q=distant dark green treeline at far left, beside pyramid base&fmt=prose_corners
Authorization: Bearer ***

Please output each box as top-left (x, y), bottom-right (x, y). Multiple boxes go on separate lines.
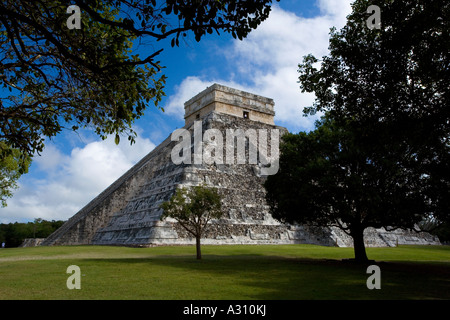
top-left (0, 219), bottom-right (65, 248)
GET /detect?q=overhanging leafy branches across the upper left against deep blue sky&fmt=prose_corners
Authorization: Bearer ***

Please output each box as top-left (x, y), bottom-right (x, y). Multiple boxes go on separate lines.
top-left (0, 0), bottom-right (278, 172)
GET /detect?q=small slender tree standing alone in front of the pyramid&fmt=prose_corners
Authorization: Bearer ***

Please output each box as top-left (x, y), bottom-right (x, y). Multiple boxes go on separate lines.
top-left (161, 186), bottom-right (223, 259)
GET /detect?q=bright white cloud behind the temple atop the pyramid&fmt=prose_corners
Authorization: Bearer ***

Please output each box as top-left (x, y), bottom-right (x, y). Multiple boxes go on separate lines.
top-left (167, 0), bottom-right (351, 132)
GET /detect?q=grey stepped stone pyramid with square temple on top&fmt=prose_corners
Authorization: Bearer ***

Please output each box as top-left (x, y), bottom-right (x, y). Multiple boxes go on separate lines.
top-left (41, 84), bottom-right (439, 246)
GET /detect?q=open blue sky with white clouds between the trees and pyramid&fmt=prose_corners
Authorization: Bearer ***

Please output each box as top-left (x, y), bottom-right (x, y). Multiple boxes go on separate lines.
top-left (0, 0), bottom-right (352, 223)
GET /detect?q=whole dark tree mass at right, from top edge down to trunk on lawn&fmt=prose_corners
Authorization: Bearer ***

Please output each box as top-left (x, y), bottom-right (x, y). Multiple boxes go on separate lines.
top-left (266, 0), bottom-right (450, 261)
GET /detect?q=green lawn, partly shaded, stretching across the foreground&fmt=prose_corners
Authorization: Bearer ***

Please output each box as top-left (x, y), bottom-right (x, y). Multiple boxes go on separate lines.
top-left (0, 245), bottom-right (450, 300)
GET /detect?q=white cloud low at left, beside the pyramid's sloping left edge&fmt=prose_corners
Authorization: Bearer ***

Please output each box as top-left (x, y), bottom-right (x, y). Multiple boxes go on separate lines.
top-left (0, 133), bottom-right (155, 223)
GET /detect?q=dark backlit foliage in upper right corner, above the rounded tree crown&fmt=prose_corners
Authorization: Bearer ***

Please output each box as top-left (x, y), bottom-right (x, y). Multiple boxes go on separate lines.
top-left (299, 0), bottom-right (450, 221)
